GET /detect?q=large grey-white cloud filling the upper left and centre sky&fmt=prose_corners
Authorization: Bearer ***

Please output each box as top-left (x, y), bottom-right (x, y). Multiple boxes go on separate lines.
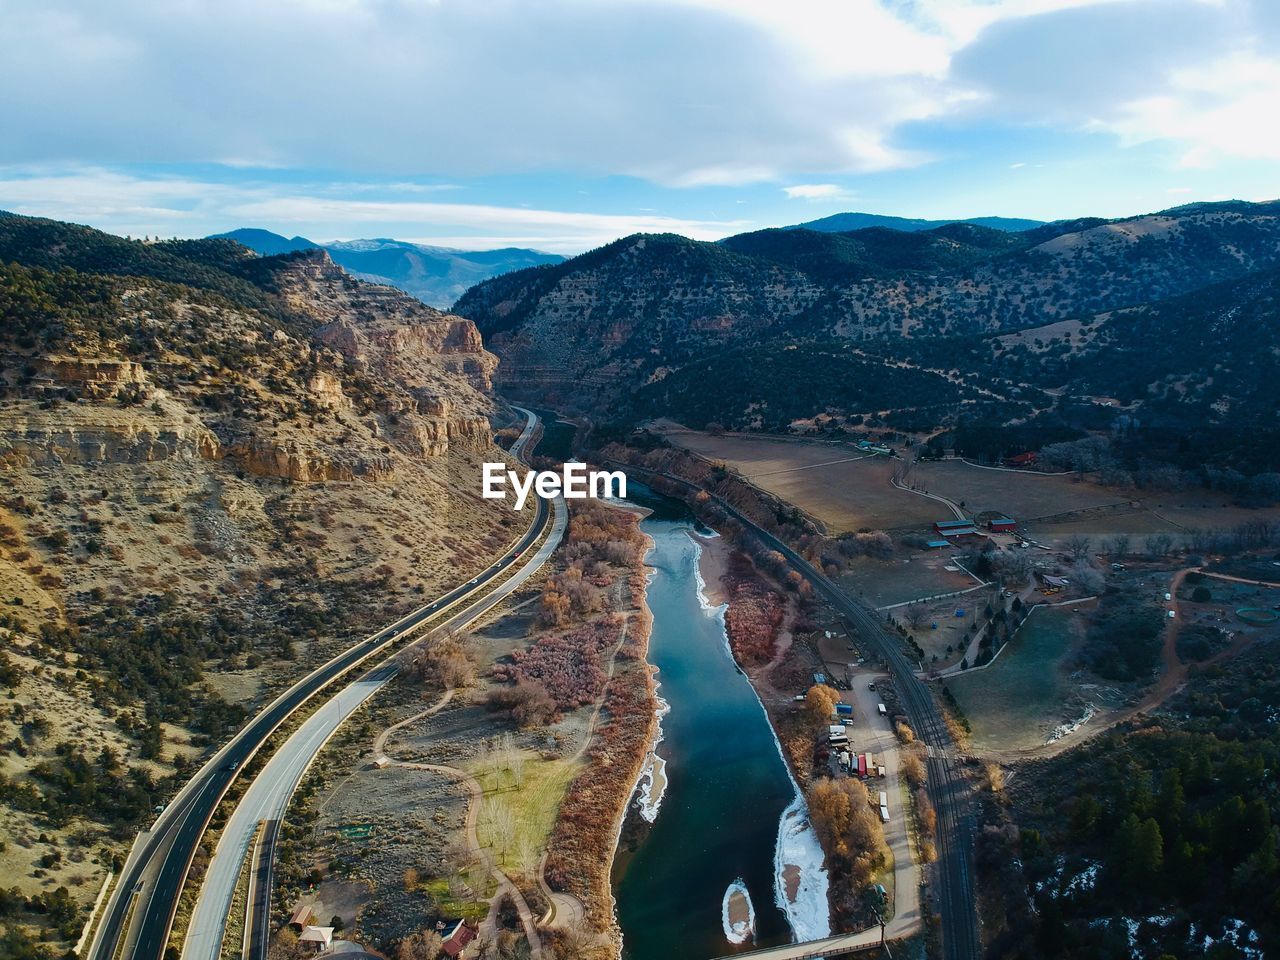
top-left (0, 0), bottom-right (1095, 187)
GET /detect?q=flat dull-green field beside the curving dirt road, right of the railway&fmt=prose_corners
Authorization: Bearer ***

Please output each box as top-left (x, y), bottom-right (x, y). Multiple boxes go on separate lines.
top-left (947, 607), bottom-right (1121, 754)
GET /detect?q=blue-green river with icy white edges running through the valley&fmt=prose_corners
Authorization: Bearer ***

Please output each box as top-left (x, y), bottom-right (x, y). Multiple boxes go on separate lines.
top-left (613, 488), bottom-right (827, 960)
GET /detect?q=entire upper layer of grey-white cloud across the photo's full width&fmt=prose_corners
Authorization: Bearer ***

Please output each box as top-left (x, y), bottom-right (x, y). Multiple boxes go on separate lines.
top-left (0, 0), bottom-right (1280, 202)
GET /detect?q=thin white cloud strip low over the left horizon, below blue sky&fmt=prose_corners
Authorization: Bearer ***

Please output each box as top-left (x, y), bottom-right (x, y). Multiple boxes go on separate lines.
top-left (0, 168), bottom-right (751, 252)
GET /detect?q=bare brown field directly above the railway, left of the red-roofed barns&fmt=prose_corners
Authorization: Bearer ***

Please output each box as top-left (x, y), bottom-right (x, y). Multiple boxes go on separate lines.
top-left (666, 430), bottom-right (951, 534)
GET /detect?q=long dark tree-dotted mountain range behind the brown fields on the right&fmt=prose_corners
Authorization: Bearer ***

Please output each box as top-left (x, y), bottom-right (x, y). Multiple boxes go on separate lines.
top-left (454, 202), bottom-right (1280, 463)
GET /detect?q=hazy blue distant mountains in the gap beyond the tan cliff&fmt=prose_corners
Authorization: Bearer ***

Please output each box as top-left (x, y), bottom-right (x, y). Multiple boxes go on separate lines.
top-left (215, 228), bottom-right (564, 307)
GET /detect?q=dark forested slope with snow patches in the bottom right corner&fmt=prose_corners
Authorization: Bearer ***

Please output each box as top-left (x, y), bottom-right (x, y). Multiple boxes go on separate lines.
top-left (978, 648), bottom-right (1280, 960)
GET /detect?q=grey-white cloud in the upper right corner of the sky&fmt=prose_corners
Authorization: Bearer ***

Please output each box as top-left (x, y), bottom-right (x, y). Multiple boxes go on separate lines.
top-left (951, 0), bottom-right (1280, 166)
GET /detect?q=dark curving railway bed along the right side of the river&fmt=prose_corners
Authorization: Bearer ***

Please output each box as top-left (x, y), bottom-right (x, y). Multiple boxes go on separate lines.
top-left (612, 461), bottom-right (982, 960)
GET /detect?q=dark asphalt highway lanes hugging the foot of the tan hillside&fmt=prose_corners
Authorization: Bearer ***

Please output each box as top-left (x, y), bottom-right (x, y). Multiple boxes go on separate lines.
top-left (88, 407), bottom-right (550, 960)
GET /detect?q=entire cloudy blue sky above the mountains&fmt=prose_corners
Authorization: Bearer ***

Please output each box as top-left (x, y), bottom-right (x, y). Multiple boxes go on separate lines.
top-left (0, 0), bottom-right (1280, 253)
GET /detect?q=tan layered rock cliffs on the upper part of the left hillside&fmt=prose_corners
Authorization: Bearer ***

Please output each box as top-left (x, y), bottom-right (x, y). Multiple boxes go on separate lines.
top-left (0, 240), bottom-right (498, 483)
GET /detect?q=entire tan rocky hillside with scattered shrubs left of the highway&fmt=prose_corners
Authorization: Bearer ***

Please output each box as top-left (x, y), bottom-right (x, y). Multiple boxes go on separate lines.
top-left (0, 215), bottom-right (518, 952)
